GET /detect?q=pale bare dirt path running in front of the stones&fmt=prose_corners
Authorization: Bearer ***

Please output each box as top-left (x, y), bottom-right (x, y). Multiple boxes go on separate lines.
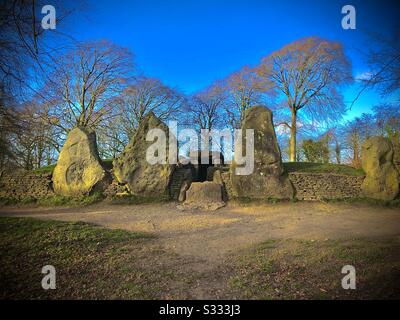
top-left (0, 202), bottom-right (400, 267)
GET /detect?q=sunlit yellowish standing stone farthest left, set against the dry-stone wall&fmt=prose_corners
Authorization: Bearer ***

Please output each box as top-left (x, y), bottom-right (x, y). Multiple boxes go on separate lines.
top-left (53, 128), bottom-right (106, 196)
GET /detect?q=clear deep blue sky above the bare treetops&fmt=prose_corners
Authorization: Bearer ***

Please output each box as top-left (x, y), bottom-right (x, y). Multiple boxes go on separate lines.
top-left (60, 0), bottom-right (400, 118)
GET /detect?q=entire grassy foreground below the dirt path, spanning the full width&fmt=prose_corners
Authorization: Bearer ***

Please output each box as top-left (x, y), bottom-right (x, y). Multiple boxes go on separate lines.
top-left (0, 218), bottom-right (400, 299)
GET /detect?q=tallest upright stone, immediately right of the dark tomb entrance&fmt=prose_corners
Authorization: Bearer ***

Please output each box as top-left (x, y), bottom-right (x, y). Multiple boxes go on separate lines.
top-left (231, 106), bottom-right (294, 199)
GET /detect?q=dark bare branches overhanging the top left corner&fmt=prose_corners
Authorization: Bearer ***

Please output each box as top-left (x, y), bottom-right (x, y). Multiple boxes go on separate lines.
top-left (0, 0), bottom-right (75, 97)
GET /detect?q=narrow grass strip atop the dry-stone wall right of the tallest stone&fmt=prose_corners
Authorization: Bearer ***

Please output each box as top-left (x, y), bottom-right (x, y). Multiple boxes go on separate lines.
top-left (283, 162), bottom-right (365, 177)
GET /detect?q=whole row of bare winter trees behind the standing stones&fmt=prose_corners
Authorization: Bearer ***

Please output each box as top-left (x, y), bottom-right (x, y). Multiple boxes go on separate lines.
top-left (0, 0), bottom-right (399, 174)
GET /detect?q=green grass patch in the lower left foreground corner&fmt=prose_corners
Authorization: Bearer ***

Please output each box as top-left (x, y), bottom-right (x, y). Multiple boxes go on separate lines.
top-left (0, 218), bottom-right (155, 299)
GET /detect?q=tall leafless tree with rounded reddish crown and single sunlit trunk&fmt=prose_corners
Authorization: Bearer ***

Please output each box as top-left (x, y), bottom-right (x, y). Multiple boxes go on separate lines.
top-left (257, 37), bottom-right (351, 161)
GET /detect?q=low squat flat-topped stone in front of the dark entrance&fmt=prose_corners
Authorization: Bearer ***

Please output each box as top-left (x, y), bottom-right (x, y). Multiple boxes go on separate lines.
top-left (178, 181), bottom-right (225, 210)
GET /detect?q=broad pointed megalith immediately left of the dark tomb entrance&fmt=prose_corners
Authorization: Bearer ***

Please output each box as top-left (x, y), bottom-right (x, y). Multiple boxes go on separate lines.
top-left (113, 112), bottom-right (176, 198)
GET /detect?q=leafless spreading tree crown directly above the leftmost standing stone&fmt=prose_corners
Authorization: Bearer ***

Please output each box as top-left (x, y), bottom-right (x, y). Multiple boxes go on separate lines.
top-left (44, 41), bottom-right (133, 131)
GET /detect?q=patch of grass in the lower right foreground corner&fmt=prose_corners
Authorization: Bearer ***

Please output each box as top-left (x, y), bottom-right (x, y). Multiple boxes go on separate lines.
top-left (229, 239), bottom-right (400, 299)
